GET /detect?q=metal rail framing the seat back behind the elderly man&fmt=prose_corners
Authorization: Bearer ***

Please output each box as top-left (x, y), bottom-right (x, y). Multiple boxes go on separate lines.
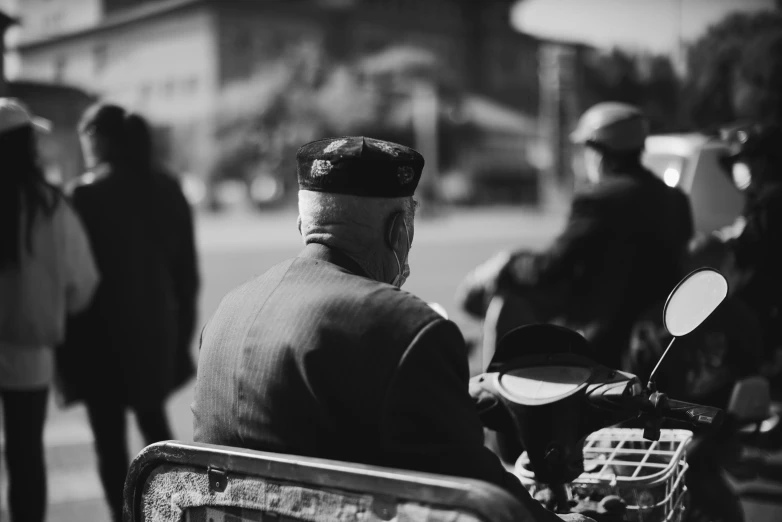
top-left (123, 441), bottom-right (532, 522)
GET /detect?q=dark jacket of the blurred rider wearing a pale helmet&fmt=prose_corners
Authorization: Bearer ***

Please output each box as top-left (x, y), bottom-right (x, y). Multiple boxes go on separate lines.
top-left (507, 165), bottom-right (693, 368)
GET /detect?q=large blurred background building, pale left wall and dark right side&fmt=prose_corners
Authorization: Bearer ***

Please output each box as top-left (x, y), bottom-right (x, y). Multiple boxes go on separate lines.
top-left (7, 0), bottom-right (539, 184)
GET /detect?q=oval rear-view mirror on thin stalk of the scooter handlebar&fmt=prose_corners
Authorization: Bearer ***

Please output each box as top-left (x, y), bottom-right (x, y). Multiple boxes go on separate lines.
top-left (663, 268), bottom-right (728, 337)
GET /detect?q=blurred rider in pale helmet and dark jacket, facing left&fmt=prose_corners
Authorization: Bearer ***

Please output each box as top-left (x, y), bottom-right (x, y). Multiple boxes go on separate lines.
top-left (461, 102), bottom-right (693, 374)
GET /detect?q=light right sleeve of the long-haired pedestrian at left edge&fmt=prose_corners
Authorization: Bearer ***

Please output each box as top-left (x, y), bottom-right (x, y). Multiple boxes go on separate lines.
top-left (59, 200), bottom-right (100, 314)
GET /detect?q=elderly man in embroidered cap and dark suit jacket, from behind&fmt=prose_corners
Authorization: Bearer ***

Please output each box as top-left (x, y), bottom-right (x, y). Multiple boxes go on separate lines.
top-left (193, 137), bottom-right (588, 520)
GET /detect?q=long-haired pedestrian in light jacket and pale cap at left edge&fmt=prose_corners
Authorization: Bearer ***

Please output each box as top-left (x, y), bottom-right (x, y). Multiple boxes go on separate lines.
top-left (0, 98), bottom-right (98, 522)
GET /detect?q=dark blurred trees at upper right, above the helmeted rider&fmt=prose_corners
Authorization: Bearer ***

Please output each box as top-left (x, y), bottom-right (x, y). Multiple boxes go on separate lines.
top-left (582, 8), bottom-right (782, 132)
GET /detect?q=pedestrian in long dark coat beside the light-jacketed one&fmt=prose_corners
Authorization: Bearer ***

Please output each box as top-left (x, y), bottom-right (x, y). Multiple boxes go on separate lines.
top-left (58, 105), bottom-right (199, 520)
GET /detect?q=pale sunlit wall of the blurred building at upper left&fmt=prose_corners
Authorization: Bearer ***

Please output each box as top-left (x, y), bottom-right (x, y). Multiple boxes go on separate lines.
top-left (15, 0), bottom-right (216, 179)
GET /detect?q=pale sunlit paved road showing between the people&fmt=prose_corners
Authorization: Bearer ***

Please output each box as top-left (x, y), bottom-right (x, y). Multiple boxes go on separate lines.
top-left (0, 205), bottom-right (782, 522)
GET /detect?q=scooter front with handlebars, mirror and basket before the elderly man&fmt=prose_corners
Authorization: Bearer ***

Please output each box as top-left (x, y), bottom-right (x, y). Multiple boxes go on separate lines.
top-left (470, 269), bottom-right (728, 521)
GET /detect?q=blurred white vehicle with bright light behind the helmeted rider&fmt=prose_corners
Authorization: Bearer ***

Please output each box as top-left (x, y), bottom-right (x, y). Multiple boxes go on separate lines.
top-left (643, 133), bottom-right (744, 233)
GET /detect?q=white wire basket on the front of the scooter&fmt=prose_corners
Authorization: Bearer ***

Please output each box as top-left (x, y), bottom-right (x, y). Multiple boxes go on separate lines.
top-left (515, 428), bottom-right (692, 522)
